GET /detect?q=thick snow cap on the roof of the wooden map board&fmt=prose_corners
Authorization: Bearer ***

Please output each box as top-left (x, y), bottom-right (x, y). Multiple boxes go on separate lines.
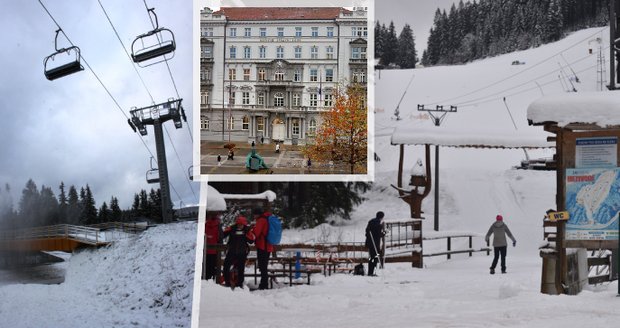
top-left (527, 91), bottom-right (620, 127)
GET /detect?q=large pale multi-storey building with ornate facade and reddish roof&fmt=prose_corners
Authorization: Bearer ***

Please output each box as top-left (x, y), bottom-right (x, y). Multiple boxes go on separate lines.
top-left (200, 7), bottom-right (368, 144)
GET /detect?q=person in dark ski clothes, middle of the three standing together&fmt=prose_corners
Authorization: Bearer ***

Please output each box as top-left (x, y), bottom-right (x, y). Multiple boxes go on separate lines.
top-left (224, 216), bottom-right (255, 287)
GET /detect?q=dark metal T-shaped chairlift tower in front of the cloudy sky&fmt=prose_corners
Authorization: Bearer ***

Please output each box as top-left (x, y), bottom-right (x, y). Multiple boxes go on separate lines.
top-left (130, 99), bottom-right (187, 223)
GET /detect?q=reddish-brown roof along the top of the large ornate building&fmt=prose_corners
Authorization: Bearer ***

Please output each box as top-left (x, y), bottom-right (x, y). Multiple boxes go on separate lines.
top-left (213, 7), bottom-right (350, 21)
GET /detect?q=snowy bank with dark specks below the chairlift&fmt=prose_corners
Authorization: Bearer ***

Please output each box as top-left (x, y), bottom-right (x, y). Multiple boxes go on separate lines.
top-left (0, 222), bottom-right (196, 328)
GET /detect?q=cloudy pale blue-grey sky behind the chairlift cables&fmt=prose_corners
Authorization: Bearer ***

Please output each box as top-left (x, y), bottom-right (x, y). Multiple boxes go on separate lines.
top-left (0, 0), bottom-right (199, 208)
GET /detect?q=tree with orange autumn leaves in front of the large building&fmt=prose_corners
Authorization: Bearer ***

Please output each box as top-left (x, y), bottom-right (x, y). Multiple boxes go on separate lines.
top-left (304, 85), bottom-right (368, 174)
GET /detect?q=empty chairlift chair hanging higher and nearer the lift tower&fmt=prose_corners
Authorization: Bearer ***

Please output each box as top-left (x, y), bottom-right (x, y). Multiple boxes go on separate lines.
top-left (131, 8), bottom-right (176, 67)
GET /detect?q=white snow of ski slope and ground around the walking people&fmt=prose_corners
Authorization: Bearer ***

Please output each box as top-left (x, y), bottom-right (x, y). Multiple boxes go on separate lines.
top-left (199, 28), bottom-right (620, 328)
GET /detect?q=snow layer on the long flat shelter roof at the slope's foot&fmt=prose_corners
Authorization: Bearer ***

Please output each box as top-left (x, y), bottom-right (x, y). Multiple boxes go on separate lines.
top-left (392, 127), bottom-right (555, 148)
